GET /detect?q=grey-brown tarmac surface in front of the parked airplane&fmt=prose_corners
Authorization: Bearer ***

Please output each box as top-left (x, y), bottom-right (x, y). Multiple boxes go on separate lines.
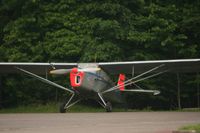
top-left (0, 112), bottom-right (200, 133)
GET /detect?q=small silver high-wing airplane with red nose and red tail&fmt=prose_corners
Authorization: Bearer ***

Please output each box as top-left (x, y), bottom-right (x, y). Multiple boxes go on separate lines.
top-left (0, 59), bottom-right (200, 113)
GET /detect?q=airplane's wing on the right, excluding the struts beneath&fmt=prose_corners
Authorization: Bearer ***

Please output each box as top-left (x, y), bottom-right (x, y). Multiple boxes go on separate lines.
top-left (98, 59), bottom-right (200, 74)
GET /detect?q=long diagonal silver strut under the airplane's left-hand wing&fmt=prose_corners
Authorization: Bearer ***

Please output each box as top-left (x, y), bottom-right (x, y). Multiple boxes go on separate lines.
top-left (15, 67), bottom-right (74, 94)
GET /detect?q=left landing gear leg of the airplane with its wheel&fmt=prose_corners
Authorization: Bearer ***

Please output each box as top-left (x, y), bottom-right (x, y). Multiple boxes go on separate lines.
top-left (60, 94), bottom-right (81, 113)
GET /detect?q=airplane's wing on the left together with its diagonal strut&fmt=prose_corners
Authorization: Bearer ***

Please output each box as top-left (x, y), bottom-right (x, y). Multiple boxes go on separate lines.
top-left (0, 62), bottom-right (77, 93)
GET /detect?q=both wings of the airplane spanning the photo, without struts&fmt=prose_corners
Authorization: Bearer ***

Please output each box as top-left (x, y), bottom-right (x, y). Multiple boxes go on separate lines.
top-left (0, 59), bottom-right (200, 74)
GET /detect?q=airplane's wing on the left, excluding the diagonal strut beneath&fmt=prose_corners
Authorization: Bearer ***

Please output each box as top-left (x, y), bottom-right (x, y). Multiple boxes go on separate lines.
top-left (0, 62), bottom-right (77, 75)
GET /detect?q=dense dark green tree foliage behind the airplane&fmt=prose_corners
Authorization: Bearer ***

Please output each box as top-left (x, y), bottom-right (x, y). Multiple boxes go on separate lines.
top-left (0, 0), bottom-right (200, 109)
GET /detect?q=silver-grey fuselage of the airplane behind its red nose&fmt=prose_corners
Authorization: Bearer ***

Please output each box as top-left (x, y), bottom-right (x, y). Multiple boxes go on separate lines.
top-left (74, 70), bottom-right (122, 103)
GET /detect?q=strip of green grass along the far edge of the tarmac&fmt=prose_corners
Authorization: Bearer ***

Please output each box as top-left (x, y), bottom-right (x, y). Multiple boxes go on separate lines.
top-left (0, 103), bottom-right (200, 113)
